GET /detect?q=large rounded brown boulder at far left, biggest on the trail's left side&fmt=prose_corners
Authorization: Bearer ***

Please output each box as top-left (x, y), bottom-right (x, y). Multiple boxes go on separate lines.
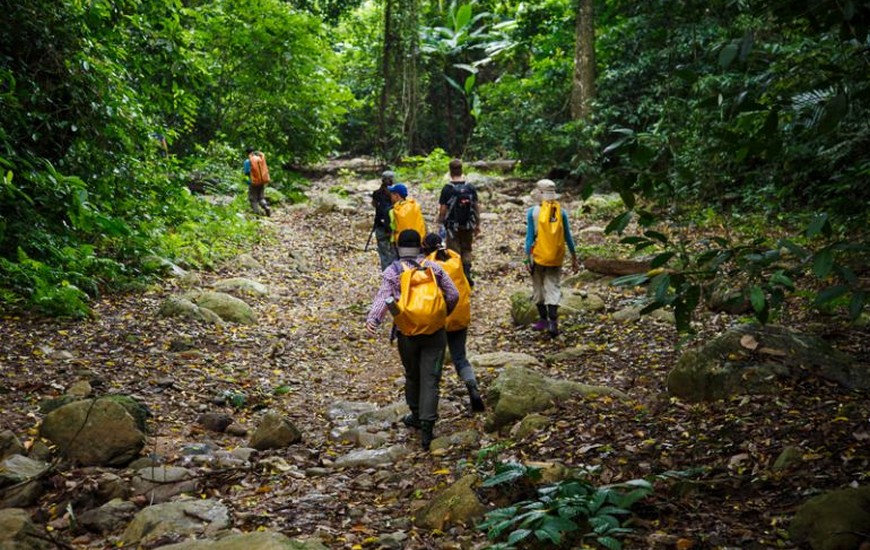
top-left (40, 397), bottom-right (145, 466)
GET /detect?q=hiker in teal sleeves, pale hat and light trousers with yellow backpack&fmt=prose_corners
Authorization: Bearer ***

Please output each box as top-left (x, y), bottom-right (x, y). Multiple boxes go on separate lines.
top-left (525, 179), bottom-right (580, 337)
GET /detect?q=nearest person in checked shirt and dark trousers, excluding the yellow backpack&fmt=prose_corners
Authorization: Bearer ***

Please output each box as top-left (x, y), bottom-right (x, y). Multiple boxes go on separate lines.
top-left (366, 229), bottom-right (459, 451)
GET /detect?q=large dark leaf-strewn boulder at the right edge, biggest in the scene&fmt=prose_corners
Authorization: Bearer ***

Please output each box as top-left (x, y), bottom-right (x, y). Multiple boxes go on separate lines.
top-left (668, 325), bottom-right (870, 402)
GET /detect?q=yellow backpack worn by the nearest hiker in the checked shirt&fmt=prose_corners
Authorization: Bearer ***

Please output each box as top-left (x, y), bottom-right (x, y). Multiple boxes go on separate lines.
top-left (393, 262), bottom-right (447, 336)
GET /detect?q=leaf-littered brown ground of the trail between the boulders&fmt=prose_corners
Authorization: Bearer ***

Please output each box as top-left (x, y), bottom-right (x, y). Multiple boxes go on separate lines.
top-left (0, 170), bottom-right (870, 549)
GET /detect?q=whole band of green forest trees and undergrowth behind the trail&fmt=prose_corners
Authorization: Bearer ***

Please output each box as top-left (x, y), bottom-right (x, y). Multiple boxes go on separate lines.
top-left (0, 0), bottom-right (870, 315)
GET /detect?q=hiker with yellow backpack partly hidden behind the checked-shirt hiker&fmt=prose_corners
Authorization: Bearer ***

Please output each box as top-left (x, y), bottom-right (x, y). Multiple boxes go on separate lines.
top-left (423, 233), bottom-right (486, 412)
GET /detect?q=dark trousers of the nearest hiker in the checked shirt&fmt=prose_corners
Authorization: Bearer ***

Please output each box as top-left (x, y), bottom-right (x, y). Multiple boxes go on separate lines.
top-left (398, 329), bottom-right (447, 422)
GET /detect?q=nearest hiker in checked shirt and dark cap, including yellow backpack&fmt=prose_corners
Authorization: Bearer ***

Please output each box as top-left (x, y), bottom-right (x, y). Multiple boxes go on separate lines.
top-left (366, 229), bottom-right (459, 451)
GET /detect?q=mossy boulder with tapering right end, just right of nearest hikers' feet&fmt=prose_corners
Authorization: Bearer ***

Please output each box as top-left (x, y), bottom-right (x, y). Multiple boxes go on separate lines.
top-left (484, 367), bottom-right (627, 432)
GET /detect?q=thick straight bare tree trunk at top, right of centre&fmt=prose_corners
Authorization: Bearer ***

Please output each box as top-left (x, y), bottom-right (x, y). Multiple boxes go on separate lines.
top-left (571, 0), bottom-right (595, 120)
